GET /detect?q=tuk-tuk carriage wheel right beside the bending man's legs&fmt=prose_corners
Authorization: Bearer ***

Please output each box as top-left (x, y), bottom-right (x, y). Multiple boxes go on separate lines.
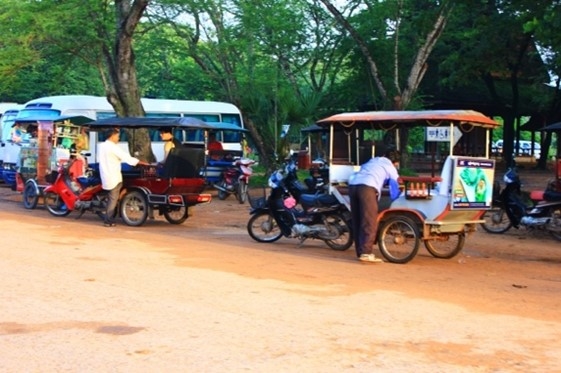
top-left (378, 216), bottom-right (421, 264)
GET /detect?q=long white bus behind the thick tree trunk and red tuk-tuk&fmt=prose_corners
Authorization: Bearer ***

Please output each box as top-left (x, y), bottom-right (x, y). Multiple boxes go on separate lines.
top-left (18, 95), bottom-right (244, 162)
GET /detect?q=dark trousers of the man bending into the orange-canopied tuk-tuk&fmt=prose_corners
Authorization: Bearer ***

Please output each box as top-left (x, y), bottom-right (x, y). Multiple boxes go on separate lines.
top-left (349, 185), bottom-right (378, 257)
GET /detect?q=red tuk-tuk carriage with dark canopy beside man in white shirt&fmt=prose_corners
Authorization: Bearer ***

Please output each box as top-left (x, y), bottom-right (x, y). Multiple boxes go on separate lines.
top-left (65, 117), bottom-right (212, 226)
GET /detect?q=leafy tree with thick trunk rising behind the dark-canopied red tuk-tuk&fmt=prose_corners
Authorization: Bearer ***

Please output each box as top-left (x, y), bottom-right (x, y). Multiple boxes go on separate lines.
top-left (0, 0), bottom-right (154, 161)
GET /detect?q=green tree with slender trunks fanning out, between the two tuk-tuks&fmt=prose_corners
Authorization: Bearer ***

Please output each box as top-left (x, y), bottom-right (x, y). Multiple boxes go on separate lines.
top-left (152, 0), bottom-right (350, 165)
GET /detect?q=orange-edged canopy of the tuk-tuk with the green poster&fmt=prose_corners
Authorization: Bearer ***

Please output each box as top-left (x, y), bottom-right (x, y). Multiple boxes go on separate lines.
top-left (317, 110), bottom-right (499, 130)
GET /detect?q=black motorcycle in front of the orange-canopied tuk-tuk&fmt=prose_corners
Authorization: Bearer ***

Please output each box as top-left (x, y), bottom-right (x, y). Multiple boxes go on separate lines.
top-left (247, 163), bottom-right (353, 251)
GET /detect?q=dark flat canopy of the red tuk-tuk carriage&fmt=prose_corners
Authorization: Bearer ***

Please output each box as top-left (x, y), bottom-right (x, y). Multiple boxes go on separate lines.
top-left (87, 117), bottom-right (214, 130)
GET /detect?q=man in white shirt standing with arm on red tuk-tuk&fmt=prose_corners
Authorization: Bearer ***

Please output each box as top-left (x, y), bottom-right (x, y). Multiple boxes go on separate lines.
top-left (97, 128), bottom-right (150, 227)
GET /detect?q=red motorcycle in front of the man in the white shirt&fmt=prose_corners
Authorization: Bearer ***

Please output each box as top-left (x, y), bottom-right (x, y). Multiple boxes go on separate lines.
top-left (43, 159), bottom-right (107, 219)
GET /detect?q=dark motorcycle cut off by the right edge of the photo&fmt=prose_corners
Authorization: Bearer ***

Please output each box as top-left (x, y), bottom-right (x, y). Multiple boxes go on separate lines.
top-left (482, 169), bottom-right (561, 241)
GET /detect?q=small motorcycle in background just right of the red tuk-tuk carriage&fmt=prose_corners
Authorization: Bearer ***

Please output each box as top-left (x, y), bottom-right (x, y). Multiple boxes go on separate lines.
top-left (213, 158), bottom-right (255, 204)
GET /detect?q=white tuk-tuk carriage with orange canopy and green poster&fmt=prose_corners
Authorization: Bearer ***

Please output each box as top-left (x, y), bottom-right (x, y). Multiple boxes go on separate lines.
top-left (317, 110), bottom-right (498, 263)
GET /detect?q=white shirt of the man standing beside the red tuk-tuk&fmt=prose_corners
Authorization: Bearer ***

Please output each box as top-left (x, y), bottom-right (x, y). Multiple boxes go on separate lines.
top-left (97, 140), bottom-right (139, 190)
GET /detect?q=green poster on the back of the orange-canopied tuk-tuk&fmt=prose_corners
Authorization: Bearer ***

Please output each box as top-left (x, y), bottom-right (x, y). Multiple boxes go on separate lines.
top-left (452, 158), bottom-right (495, 209)
